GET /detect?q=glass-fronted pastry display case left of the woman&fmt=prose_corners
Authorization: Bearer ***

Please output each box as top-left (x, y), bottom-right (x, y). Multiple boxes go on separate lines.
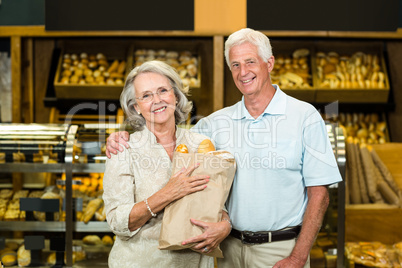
top-left (0, 124), bottom-right (125, 267)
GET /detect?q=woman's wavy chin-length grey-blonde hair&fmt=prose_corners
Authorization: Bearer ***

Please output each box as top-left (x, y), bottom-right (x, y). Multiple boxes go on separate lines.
top-left (120, 60), bottom-right (193, 131)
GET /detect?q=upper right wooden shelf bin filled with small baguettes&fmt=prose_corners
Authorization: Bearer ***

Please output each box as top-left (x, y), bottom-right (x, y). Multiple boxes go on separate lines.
top-left (312, 41), bottom-right (390, 103)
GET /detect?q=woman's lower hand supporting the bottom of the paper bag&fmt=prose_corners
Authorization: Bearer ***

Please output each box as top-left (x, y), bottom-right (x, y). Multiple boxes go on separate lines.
top-left (182, 219), bottom-right (231, 253)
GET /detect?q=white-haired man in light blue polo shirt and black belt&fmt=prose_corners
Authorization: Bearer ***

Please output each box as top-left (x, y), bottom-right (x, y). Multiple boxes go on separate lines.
top-left (107, 29), bottom-right (341, 268)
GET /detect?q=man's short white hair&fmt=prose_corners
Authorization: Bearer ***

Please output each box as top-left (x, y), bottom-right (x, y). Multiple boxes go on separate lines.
top-left (225, 28), bottom-right (272, 69)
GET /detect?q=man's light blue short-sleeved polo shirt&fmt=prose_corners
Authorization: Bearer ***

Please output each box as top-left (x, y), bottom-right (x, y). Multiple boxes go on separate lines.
top-left (192, 85), bottom-right (342, 231)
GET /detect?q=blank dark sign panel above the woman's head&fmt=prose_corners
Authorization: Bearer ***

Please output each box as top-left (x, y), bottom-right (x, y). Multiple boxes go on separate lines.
top-left (45, 0), bottom-right (194, 31)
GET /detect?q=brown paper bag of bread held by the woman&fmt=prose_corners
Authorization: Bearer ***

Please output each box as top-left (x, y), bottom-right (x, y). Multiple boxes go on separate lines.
top-left (159, 151), bottom-right (236, 258)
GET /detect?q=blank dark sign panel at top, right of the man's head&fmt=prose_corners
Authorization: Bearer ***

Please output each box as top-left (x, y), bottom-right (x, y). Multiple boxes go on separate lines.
top-left (247, 0), bottom-right (401, 31)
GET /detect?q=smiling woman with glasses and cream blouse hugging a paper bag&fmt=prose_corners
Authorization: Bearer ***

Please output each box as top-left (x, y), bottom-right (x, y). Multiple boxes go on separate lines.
top-left (103, 61), bottom-right (230, 268)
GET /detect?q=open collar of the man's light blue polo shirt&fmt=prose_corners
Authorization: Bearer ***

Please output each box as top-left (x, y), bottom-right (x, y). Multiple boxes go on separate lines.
top-left (232, 84), bottom-right (287, 119)
